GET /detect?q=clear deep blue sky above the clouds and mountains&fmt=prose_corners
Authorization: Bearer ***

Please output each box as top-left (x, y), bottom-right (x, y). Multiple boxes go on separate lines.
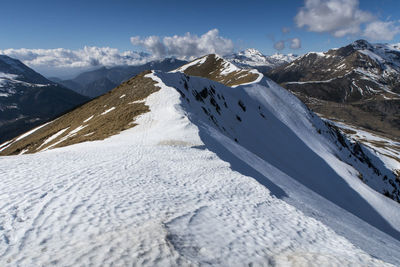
top-left (0, 0), bottom-right (400, 76)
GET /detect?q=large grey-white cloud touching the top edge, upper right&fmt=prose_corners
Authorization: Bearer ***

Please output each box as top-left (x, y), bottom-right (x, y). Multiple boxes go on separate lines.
top-left (295, 0), bottom-right (374, 37)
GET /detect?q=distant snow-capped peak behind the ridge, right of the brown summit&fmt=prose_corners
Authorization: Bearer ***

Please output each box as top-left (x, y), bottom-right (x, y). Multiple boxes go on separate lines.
top-left (224, 48), bottom-right (297, 73)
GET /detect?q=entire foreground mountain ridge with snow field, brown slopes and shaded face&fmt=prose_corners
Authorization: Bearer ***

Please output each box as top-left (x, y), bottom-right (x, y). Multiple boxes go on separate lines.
top-left (0, 55), bottom-right (400, 266)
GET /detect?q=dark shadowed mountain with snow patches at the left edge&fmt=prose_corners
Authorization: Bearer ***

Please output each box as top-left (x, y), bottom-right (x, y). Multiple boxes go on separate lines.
top-left (0, 55), bottom-right (88, 146)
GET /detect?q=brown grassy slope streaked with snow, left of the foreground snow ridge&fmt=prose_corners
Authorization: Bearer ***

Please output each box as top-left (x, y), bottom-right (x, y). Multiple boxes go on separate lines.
top-left (0, 71), bottom-right (159, 156)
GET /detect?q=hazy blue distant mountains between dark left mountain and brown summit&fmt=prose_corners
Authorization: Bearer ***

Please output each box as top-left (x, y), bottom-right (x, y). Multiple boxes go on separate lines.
top-left (50, 58), bottom-right (187, 98)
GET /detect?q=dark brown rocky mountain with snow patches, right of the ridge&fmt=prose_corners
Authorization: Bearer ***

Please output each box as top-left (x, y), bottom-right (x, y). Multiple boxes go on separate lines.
top-left (268, 40), bottom-right (400, 141)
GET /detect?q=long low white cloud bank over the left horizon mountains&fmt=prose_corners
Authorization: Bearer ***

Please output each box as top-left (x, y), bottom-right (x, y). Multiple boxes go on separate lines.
top-left (0, 46), bottom-right (150, 76)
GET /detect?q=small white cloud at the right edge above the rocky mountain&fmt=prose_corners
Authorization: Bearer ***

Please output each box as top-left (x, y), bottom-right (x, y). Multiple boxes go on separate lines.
top-left (363, 21), bottom-right (400, 41)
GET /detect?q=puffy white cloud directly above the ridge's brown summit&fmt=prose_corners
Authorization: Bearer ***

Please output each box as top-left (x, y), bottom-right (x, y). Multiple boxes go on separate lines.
top-left (131, 29), bottom-right (234, 59)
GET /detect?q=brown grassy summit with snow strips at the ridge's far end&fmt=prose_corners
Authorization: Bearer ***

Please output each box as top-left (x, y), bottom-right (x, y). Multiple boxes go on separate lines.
top-left (179, 54), bottom-right (258, 86)
